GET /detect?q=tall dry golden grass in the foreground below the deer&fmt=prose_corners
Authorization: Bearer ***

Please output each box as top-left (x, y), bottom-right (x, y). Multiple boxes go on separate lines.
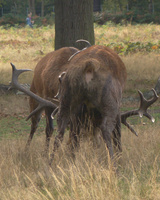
top-left (0, 124), bottom-right (160, 200)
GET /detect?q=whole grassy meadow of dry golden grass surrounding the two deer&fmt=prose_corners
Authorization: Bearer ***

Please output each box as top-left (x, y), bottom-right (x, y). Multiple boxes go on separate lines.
top-left (0, 23), bottom-right (160, 200)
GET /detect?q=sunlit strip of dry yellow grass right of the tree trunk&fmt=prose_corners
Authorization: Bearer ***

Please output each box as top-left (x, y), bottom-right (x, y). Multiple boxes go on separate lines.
top-left (95, 23), bottom-right (160, 45)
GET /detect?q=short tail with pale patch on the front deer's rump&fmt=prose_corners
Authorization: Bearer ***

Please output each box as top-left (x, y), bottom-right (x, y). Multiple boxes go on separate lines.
top-left (84, 61), bottom-right (100, 84)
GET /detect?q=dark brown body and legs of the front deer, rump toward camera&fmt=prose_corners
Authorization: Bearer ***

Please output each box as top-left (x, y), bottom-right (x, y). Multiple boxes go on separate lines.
top-left (51, 45), bottom-right (127, 166)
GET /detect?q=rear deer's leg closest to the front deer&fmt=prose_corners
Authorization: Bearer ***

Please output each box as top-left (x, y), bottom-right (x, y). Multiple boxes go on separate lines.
top-left (45, 108), bottom-right (54, 153)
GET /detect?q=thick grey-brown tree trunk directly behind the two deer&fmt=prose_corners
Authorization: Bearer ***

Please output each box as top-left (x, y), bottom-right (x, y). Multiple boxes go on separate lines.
top-left (55, 0), bottom-right (95, 49)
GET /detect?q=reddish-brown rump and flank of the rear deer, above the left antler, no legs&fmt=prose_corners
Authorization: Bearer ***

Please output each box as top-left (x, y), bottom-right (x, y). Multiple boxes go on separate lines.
top-left (31, 47), bottom-right (78, 98)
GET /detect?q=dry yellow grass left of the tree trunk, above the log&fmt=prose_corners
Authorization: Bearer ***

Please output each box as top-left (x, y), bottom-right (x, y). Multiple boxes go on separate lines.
top-left (0, 27), bottom-right (54, 84)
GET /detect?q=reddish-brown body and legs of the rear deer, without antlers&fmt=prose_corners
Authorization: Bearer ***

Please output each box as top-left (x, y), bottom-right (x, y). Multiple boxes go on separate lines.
top-left (26, 47), bottom-right (78, 151)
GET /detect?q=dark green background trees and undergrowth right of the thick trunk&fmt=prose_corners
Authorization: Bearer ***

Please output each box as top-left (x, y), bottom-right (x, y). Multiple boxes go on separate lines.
top-left (94, 0), bottom-right (160, 24)
